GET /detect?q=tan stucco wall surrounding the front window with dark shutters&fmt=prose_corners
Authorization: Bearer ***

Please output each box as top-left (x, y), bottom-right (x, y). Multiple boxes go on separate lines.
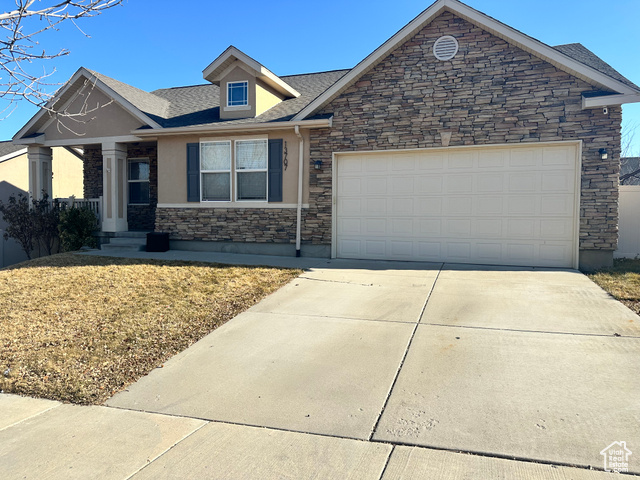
top-left (158, 129), bottom-right (309, 207)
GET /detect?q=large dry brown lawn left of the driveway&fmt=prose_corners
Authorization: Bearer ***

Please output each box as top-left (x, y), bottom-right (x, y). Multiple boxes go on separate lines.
top-left (0, 253), bottom-right (300, 404)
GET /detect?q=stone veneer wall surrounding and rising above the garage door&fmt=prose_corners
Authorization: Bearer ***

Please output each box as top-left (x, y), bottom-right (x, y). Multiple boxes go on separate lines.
top-left (302, 12), bottom-right (622, 250)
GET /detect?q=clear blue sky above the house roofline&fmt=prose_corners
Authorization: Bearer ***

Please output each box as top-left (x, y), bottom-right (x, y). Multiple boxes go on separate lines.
top-left (0, 0), bottom-right (640, 156)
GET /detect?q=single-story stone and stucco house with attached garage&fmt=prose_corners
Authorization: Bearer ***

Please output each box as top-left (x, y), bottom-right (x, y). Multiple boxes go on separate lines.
top-left (13, 0), bottom-right (640, 269)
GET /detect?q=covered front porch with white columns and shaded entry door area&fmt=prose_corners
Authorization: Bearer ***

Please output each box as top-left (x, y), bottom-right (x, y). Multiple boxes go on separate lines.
top-left (27, 142), bottom-right (158, 236)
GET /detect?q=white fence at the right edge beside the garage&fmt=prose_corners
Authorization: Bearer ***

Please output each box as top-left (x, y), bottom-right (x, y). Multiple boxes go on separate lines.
top-left (614, 185), bottom-right (640, 258)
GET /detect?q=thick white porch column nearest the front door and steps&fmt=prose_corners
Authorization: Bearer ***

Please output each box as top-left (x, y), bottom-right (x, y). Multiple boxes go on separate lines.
top-left (102, 142), bottom-right (129, 232)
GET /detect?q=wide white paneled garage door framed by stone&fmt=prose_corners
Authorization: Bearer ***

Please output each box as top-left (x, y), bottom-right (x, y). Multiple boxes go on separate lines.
top-left (334, 144), bottom-right (578, 267)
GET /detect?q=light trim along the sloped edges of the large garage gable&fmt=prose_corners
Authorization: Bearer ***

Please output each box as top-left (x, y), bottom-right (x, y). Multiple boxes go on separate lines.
top-left (293, 0), bottom-right (640, 120)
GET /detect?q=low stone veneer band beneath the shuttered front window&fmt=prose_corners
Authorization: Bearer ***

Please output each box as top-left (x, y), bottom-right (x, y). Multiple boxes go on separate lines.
top-left (156, 208), bottom-right (296, 243)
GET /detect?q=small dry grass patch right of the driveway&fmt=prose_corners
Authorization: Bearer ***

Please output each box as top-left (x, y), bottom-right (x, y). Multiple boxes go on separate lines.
top-left (589, 259), bottom-right (640, 314)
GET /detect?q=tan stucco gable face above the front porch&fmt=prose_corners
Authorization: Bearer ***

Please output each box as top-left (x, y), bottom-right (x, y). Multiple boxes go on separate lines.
top-left (44, 89), bottom-right (143, 141)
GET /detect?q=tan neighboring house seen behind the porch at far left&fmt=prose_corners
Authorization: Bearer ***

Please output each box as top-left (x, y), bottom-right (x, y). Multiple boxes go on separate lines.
top-left (0, 141), bottom-right (83, 267)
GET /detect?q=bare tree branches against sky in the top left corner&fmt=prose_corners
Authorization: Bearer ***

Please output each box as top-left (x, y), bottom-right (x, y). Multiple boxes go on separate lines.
top-left (0, 0), bottom-right (124, 117)
